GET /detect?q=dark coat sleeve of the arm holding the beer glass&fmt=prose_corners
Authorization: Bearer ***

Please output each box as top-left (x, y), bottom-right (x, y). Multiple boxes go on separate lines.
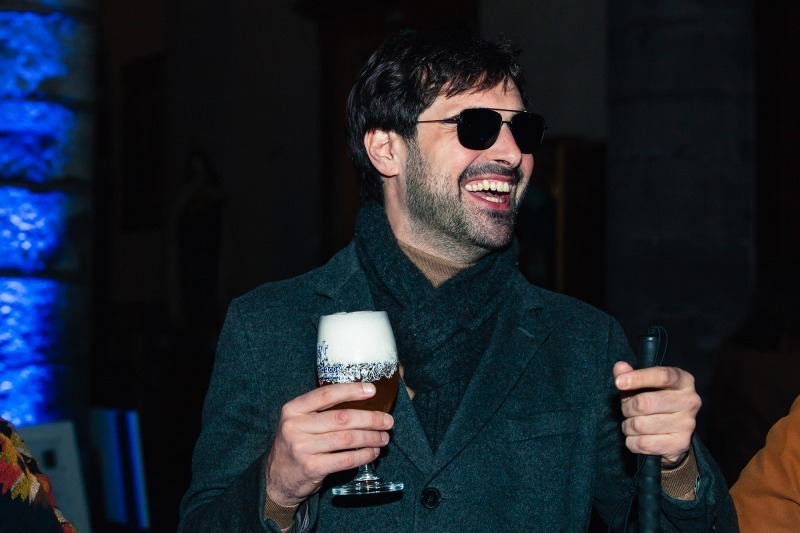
top-left (178, 301), bottom-right (292, 533)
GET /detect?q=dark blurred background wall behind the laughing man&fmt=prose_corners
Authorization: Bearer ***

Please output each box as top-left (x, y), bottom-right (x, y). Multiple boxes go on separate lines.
top-left (3, 0), bottom-right (800, 531)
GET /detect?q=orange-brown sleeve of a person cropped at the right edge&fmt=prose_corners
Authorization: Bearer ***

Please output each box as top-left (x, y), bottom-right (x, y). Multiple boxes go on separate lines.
top-left (731, 396), bottom-right (800, 532)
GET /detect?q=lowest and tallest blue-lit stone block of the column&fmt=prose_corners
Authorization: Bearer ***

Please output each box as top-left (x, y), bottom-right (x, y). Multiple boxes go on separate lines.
top-left (0, 278), bottom-right (64, 426)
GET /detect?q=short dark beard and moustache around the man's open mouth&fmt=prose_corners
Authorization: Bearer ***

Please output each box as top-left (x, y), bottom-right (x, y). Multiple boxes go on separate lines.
top-left (405, 136), bottom-right (524, 257)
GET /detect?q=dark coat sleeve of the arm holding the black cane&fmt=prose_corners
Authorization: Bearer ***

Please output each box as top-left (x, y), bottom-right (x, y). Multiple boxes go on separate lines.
top-left (595, 321), bottom-right (738, 533)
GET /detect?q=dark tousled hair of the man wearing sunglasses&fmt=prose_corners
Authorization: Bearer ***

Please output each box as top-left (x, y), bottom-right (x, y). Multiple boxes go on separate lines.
top-left (347, 29), bottom-right (528, 203)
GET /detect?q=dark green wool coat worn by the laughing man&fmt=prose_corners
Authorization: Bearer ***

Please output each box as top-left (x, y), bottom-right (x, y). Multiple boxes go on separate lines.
top-left (180, 245), bottom-right (736, 533)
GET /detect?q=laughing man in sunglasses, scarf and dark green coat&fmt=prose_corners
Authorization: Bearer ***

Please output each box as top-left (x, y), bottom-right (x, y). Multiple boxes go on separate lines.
top-left (180, 31), bottom-right (735, 532)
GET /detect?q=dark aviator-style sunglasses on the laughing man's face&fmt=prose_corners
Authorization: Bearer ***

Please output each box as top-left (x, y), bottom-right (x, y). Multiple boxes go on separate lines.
top-left (417, 107), bottom-right (547, 154)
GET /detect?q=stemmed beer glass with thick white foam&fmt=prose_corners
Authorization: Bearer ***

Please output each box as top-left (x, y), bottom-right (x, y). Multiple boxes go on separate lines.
top-left (317, 311), bottom-right (403, 496)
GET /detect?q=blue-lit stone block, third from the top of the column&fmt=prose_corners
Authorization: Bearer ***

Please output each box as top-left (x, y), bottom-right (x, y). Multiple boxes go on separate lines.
top-left (0, 186), bottom-right (67, 273)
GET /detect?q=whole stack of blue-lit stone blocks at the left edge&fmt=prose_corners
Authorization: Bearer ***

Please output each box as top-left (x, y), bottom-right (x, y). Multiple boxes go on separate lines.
top-left (0, 5), bottom-right (80, 426)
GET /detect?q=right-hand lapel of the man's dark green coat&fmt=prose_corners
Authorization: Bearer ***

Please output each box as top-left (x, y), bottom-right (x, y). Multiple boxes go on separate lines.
top-left (426, 279), bottom-right (551, 474)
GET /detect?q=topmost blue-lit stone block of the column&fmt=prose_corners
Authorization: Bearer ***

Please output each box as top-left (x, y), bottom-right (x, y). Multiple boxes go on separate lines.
top-left (0, 12), bottom-right (76, 98)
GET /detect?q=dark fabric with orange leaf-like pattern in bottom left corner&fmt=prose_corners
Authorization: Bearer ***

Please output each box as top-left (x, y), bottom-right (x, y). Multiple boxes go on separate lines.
top-left (0, 419), bottom-right (76, 533)
